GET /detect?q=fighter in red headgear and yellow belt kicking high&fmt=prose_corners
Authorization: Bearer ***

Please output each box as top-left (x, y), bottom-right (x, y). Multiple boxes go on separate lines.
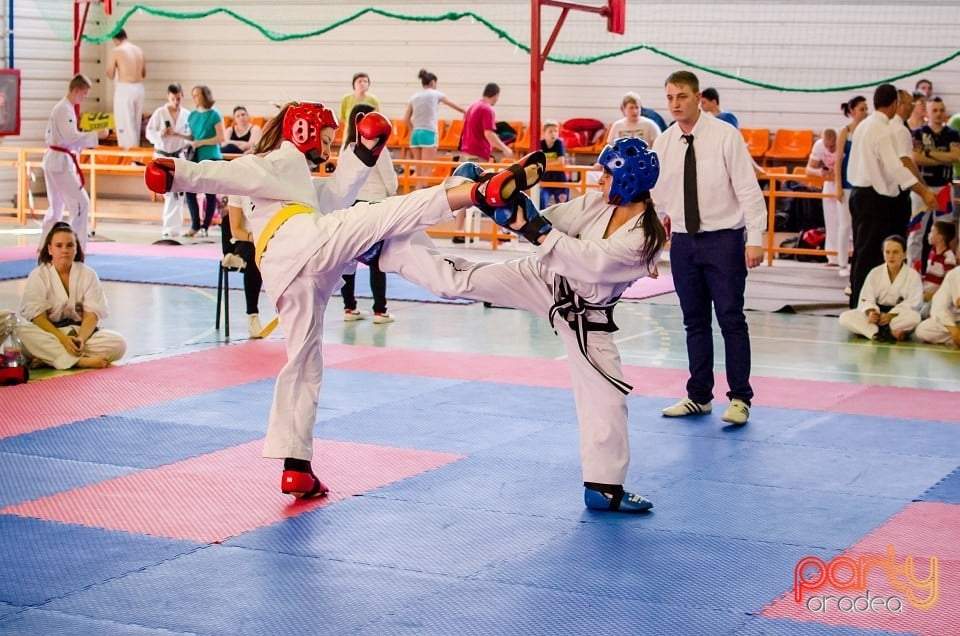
top-left (145, 102), bottom-right (546, 498)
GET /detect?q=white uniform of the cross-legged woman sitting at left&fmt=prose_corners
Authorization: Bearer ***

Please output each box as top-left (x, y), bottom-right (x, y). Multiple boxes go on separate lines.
top-left (20, 262), bottom-right (127, 369)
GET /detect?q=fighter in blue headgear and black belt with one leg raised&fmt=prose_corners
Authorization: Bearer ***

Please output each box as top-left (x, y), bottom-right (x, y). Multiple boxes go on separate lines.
top-left (380, 139), bottom-right (666, 512)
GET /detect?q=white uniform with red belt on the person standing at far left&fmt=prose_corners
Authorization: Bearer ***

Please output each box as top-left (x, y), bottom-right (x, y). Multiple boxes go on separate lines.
top-left (40, 97), bottom-right (99, 250)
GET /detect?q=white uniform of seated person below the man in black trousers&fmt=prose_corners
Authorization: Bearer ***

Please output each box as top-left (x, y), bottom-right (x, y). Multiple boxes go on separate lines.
top-left (840, 263), bottom-right (923, 338)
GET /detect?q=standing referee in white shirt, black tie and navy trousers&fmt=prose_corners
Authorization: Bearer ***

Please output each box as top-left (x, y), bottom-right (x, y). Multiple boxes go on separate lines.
top-left (651, 71), bottom-right (767, 424)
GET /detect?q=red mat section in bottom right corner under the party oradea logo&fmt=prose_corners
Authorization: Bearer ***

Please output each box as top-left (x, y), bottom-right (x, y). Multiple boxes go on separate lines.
top-left (763, 502), bottom-right (960, 636)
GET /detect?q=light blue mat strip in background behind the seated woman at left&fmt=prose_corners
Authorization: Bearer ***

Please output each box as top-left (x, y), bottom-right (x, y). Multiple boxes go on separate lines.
top-left (0, 254), bottom-right (474, 304)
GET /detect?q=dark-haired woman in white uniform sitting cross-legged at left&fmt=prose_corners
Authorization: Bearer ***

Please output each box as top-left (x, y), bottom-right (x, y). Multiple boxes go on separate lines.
top-left (20, 222), bottom-right (127, 369)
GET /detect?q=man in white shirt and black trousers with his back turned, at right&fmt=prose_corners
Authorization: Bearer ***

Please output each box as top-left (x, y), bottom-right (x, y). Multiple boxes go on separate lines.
top-left (847, 84), bottom-right (937, 309)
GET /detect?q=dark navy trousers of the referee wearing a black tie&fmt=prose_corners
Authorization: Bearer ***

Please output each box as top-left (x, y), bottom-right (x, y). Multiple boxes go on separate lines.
top-left (670, 228), bottom-right (753, 404)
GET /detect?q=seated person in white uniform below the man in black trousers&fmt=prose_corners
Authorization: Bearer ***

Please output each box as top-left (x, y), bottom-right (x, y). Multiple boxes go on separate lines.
top-left (840, 235), bottom-right (923, 342)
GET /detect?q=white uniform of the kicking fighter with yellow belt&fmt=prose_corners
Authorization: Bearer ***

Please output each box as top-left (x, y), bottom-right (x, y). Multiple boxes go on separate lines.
top-left (172, 141), bottom-right (466, 460)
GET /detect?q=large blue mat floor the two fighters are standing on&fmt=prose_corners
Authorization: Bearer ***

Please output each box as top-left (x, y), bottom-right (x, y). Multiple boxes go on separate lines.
top-left (0, 369), bottom-right (957, 636)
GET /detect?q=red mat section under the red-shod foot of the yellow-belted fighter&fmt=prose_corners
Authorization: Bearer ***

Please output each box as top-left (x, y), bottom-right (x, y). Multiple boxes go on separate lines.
top-left (0, 440), bottom-right (463, 543)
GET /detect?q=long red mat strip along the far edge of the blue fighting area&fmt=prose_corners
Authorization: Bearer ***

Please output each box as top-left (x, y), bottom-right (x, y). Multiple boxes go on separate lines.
top-left (0, 340), bottom-right (960, 438)
